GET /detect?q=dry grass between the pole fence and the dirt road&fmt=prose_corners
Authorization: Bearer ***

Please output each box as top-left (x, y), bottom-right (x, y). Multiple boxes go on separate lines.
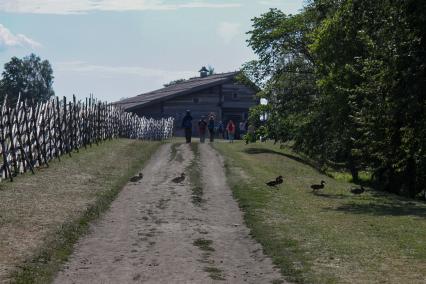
top-left (0, 139), bottom-right (161, 283)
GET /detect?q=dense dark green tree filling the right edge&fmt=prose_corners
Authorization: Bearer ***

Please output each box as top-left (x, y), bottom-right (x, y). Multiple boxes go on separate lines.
top-left (311, 0), bottom-right (426, 197)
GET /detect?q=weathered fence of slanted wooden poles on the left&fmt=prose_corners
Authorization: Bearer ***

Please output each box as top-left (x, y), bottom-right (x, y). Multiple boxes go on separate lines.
top-left (0, 96), bottom-right (174, 181)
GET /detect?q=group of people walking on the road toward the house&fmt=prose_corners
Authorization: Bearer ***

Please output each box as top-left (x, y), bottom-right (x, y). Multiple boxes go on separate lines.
top-left (182, 110), bottom-right (241, 143)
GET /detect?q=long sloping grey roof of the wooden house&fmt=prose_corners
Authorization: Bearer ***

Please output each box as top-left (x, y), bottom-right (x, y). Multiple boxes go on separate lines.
top-left (114, 71), bottom-right (238, 111)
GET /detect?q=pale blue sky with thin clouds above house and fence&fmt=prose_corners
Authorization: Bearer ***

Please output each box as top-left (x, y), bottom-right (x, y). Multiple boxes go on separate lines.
top-left (0, 0), bottom-right (304, 101)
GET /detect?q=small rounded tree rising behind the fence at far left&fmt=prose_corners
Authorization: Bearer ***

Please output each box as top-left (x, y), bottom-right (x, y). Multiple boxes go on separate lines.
top-left (0, 54), bottom-right (55, 103)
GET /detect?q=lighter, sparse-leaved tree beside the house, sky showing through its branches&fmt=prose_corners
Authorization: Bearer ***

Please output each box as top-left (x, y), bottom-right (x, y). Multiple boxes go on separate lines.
top-left (243, 9), bottom-right (316, 144)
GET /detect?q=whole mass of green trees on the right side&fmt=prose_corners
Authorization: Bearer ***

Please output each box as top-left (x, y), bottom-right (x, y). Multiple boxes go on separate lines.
top-left (244, 0), bottom-right (426, 197)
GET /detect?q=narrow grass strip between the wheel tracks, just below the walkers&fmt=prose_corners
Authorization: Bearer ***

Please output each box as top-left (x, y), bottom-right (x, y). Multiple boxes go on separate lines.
top-left (188, 143), bottom-right (203, 206)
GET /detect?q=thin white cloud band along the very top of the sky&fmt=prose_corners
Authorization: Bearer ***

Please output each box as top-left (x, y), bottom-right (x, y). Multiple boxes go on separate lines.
top-left (0, 0), bottom-right (241, 14)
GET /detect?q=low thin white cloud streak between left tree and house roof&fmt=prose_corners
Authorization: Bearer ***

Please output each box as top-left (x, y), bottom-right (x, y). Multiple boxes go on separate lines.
top-left (53, 61), bottom-right (197, 83)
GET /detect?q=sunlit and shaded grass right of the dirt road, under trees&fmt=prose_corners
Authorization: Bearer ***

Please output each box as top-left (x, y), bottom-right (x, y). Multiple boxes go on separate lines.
top-left (215, 142), bottom-right (426, 283)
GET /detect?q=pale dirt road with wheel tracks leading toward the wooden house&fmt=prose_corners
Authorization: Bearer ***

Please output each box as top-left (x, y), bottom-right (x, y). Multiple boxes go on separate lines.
top-left (55, 144), bottom-right (281, 283)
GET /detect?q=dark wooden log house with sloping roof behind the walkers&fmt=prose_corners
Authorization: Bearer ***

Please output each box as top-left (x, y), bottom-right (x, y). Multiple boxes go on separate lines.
top-left (116, 67), bottom-right (258, 135)
